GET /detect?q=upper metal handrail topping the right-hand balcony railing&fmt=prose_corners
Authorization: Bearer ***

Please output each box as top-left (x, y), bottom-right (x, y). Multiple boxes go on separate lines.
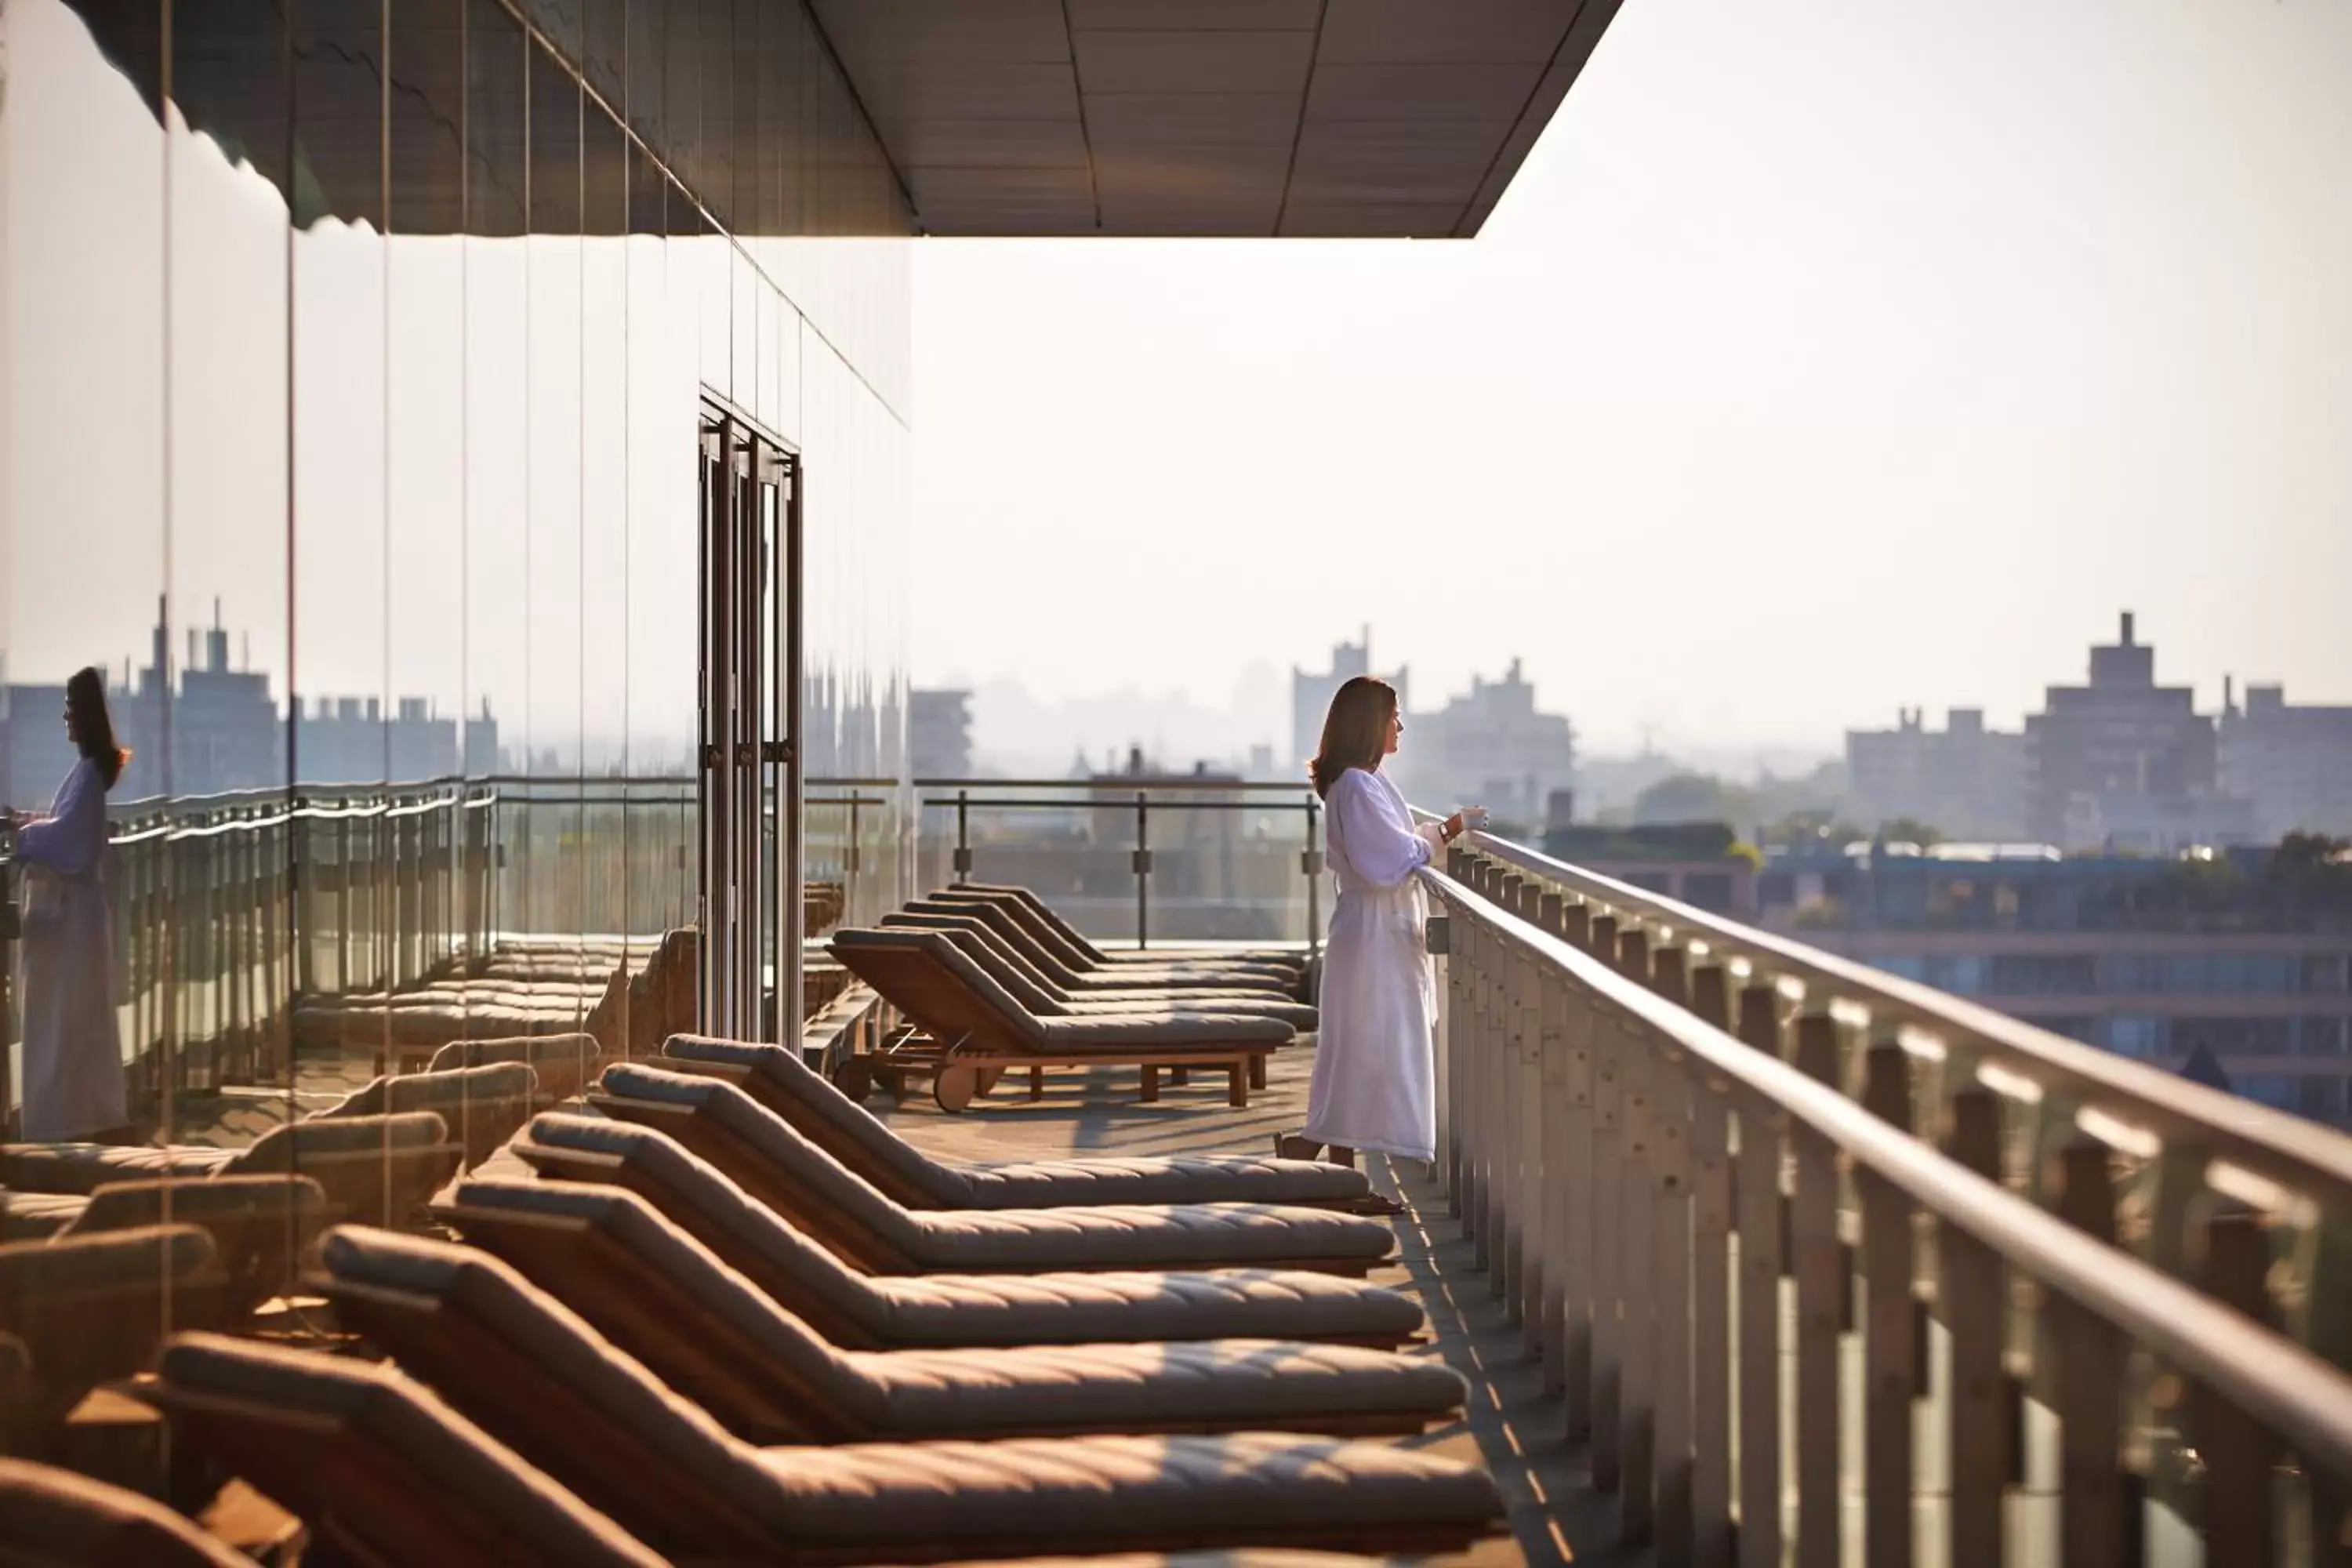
top-left (1468, 832), bottom-right (2352, 1210)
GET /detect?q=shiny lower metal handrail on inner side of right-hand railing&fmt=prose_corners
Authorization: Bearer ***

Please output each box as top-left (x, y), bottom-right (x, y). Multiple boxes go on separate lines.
top-left (1418, 867), bottom-right (2352, 1479)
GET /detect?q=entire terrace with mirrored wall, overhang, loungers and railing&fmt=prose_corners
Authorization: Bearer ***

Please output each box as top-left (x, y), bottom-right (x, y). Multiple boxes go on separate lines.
top-left (0, 0), bottom-right (2352, 1568)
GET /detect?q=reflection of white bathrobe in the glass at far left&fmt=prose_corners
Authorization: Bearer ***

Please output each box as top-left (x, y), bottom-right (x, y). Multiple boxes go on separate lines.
top-left (16, 757), bottom-right (129, 1142)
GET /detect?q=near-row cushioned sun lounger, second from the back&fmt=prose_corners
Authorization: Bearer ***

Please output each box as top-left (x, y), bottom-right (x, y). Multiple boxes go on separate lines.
top-left (567, 1062), bottom-right (1395, 1274)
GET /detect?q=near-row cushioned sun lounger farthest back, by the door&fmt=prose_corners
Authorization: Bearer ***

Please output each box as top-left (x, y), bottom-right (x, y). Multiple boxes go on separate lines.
top-left (661, 1034), bottom-right (1371, 1208)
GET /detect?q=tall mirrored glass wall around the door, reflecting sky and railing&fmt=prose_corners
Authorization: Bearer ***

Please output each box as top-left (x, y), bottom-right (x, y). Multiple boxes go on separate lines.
top-left (0, 0), bottom-right (910, 1166)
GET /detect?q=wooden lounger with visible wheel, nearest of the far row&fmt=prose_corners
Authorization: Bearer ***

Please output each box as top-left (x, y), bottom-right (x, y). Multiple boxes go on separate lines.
top-left (833, 928), bottom-right (1294, 1109)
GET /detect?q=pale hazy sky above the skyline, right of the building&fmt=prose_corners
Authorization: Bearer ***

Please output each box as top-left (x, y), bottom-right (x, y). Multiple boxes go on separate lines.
top-left (913, 0), bottom-right (2352, 748)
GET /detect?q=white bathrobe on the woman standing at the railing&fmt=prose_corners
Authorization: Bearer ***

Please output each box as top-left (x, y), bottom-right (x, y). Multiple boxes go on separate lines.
top-left (1303, 769), bottom-right (1444, 1159)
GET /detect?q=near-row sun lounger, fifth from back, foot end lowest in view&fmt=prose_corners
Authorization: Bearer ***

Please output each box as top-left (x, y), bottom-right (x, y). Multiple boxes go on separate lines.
top-left (270, 1232), bottom-right (1503, 1563)
